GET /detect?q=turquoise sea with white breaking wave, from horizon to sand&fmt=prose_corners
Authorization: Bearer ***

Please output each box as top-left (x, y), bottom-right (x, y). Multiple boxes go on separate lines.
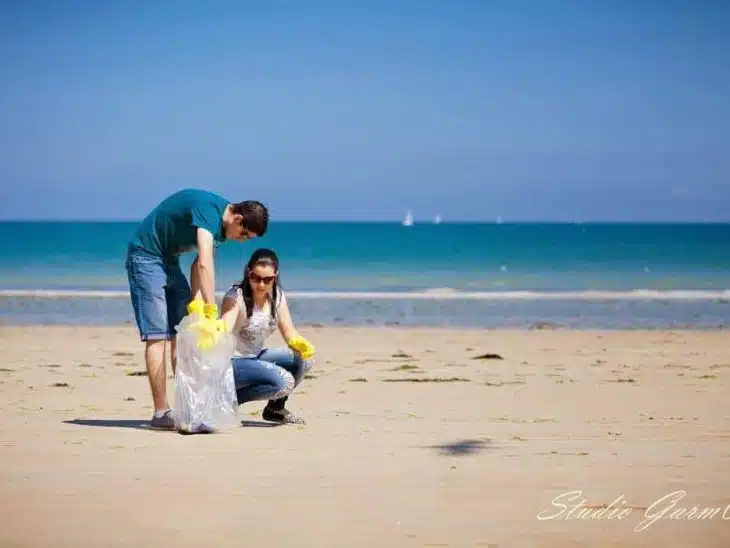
top-left (0, 222), bottom-right (730, 328)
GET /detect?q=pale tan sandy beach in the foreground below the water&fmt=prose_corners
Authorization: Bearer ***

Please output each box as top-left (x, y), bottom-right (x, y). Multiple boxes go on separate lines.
top-left (0, 327), bottom-right (730, 548)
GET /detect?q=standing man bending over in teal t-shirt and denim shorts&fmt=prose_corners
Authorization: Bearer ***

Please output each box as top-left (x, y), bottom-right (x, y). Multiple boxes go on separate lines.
top-left (126, 189), bottom-right (269, 429)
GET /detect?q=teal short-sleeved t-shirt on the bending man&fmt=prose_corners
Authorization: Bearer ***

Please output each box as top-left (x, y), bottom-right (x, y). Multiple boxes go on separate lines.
top-left (129, 188), bottom-right (230, 260)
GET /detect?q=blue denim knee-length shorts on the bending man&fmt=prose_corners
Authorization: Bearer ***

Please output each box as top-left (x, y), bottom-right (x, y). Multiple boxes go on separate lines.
top-left (126, 252), bottom-right (191, 341)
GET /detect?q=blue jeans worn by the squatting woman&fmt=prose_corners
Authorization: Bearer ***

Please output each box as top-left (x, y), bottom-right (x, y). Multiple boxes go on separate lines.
top-left (231, 348), bottom-right (313, 405)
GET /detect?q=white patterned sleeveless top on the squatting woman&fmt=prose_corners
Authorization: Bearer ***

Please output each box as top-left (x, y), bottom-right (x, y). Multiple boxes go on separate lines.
top-left (224, 287), bottom-right (283, 358)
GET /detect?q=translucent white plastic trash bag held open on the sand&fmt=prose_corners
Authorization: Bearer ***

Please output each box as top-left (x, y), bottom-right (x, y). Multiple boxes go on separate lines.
top-left (173, 315), bottom-right (238, 434)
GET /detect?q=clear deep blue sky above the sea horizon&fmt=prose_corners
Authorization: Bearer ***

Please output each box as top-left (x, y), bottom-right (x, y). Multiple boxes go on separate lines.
top-left (0, 0), bottom-right (730, 221)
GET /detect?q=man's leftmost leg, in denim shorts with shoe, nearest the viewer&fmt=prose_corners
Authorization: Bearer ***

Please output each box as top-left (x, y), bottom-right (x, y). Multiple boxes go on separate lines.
top-left (127, 256), bottom-right (174, 428)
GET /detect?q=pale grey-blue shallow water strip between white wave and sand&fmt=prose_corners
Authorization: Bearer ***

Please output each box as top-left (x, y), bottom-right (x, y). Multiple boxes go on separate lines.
top-left (0, 297), bottom-right (730, 330)
